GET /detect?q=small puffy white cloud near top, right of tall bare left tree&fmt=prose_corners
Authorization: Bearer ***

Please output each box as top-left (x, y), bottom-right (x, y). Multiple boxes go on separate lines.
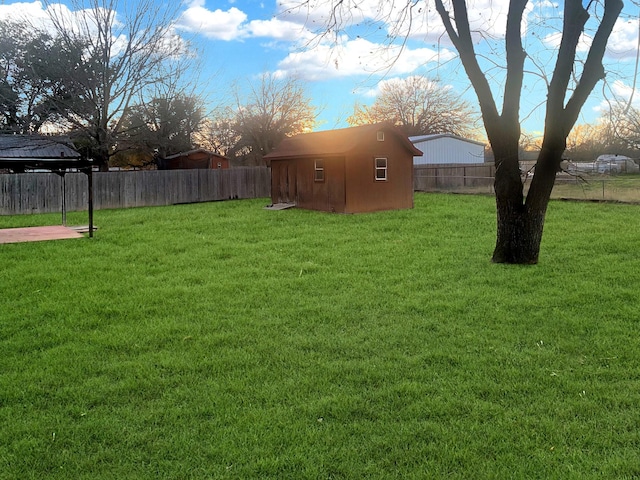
top-left (178, 5), bottom-right (247, 41)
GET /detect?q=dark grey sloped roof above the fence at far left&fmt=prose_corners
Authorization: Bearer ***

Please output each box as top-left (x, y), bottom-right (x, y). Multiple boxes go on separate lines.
top-left (0, 135), bottom-right (91, 170)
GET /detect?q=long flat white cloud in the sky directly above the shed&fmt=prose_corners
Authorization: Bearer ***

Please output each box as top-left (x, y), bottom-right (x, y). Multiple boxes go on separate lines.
top-left (276, 38), bottom-right (455, 80)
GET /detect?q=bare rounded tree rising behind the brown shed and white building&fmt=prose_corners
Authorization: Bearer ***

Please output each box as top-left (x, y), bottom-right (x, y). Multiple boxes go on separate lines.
top-left (347, 76), bottom-right (476, 137)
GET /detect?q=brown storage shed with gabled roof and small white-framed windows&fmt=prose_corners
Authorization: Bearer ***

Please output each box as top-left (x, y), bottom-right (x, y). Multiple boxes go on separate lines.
top-left (265, 123), bottom-right (422, 213)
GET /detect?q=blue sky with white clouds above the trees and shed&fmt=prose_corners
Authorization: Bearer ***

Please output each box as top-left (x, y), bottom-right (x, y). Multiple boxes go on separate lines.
top-left (0, 0), bottom-right (640, 137)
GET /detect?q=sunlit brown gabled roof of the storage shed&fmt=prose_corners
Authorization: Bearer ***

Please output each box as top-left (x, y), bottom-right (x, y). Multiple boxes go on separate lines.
top-left (264, 123), bottom-right (422, 160)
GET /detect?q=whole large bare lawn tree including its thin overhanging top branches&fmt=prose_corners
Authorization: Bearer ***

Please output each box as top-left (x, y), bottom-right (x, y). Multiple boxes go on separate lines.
top-left (287, 0), bottom-right (623, 264)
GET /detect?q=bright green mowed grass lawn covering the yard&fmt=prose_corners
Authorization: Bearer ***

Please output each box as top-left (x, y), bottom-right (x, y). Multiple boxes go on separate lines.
top-left (0, 194), bottom-right (640, 479)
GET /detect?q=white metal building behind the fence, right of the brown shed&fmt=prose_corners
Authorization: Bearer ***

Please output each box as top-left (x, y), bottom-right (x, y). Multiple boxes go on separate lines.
top-left (409, 134), bottom-right (484, 165)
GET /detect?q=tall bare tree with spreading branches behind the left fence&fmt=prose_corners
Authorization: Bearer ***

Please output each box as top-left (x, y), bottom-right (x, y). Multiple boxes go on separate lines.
top-left (38, 0), bottom-right (188, 169)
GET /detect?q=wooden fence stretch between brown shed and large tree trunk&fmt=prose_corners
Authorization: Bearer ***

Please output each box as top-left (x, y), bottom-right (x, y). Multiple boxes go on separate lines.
top-left (413, 164), bottom-right (496, 192)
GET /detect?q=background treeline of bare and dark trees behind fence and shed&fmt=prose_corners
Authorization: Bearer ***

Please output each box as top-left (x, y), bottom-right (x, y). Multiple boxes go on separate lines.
top-left (0, 0), bottom-right (640, 170)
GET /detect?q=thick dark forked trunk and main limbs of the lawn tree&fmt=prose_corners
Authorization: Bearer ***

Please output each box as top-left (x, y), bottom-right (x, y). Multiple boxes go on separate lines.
top-left (435, 0), bottom-right (622, 264)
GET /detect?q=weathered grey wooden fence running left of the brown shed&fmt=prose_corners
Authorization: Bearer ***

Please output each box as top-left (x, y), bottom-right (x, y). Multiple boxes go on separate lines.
top-left (0, 167), bottom-right (271, 215)
